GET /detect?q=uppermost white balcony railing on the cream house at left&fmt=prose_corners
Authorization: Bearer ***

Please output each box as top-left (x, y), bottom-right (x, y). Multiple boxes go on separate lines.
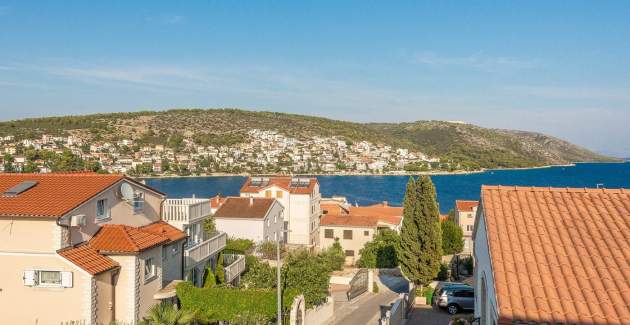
top-left (162, 198), bottom-right (211, 224)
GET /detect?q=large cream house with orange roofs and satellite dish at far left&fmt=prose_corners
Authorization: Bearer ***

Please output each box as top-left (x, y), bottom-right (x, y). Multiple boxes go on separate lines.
top-left (0, 173), bottom-right (186, 324)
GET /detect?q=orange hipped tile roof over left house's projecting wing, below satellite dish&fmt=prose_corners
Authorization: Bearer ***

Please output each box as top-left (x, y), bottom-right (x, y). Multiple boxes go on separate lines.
top-left (90, 224), bottom-right (170, 253)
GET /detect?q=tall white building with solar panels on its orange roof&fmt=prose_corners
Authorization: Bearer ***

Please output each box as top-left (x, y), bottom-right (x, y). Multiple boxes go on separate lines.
top-left (240, 176), bottom-right (321, 247)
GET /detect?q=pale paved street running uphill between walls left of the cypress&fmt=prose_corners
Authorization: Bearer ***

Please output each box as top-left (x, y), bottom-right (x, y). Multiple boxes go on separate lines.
top-left (333, 277), bottom-right (407, 325)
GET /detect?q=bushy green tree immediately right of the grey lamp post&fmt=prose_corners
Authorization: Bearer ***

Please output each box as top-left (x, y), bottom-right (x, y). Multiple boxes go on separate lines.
top-left (282, 250), bottom-right (332, 308)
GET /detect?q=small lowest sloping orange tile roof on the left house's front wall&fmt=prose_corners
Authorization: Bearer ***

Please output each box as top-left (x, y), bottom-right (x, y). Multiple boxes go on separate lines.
top-left (57, 243), bottom-right (120, 275)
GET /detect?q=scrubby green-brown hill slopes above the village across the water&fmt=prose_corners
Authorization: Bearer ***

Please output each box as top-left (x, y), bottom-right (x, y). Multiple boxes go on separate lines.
top-left (0, 109), bottom-right (614, 169)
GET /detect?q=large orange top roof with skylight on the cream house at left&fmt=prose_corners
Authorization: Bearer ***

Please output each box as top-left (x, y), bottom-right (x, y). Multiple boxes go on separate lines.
top-left (0, 173), bottom-right (124, 218)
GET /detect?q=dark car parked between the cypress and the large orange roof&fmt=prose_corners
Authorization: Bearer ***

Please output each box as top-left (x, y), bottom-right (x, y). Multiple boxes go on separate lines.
top-left (431, 282), bottom-right (475, 315)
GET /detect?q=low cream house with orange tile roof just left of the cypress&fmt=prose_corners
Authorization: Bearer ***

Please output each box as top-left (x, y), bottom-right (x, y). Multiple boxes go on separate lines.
top-left (319, 200), bottom-right (403, 265)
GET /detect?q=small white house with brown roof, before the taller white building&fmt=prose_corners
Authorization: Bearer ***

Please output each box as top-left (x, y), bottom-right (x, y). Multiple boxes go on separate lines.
top-left (214, 197), bottom-right (284, 243)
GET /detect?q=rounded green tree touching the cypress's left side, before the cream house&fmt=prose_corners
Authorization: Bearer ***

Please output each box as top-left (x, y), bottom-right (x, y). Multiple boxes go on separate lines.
top-left (357, 229), bottom-right (400, 268)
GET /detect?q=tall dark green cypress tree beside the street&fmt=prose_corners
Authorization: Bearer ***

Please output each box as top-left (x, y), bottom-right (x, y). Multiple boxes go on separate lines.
top-left (399, 176), bottom-right (442, 286)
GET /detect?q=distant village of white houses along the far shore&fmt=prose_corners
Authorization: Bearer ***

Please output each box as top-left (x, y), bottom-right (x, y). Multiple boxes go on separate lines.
top-left (0, 129), bottom-right (454, 176)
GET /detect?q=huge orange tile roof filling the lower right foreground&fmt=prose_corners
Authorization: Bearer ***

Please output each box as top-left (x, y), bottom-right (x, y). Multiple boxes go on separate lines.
top-left (476, 186), bottom-right (630, 324)
